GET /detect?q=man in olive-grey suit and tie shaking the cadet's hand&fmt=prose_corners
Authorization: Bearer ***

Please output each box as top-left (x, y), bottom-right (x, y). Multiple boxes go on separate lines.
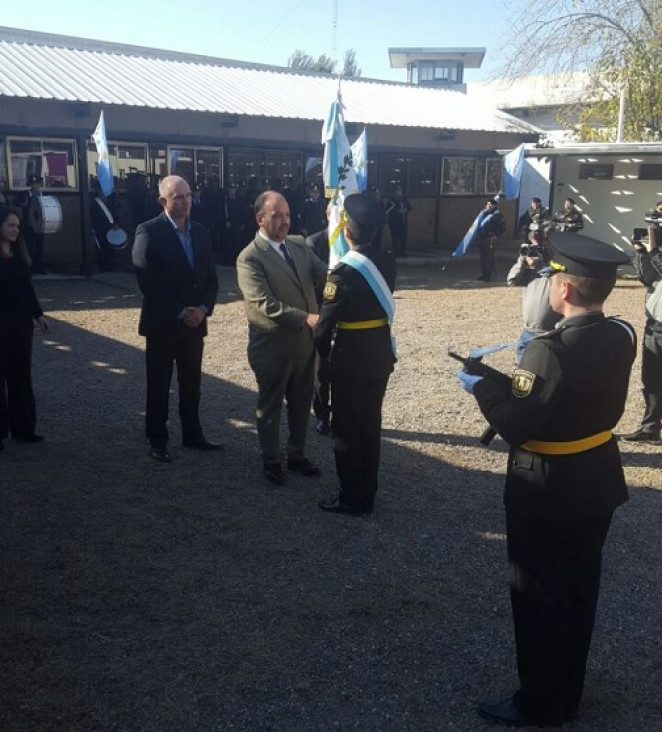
top-left (237, 191), bottom-right (326, 485)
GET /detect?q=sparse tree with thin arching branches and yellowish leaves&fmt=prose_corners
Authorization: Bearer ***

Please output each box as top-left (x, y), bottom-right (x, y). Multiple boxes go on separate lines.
top-left (501, 0), bottom-right (662, 140)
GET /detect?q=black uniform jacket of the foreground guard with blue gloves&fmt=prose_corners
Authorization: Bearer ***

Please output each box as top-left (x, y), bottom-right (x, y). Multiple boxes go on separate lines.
top-left (474, 313), bottom-right (636, 520)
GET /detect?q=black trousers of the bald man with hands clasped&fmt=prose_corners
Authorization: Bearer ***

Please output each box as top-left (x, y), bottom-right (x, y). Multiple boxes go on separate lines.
top-left (145, 323), bottom-right (204, 445)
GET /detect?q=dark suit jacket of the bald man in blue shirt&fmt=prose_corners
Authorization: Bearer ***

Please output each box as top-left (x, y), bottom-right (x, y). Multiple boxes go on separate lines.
top-left (133, 213), bottom-right (218, 336)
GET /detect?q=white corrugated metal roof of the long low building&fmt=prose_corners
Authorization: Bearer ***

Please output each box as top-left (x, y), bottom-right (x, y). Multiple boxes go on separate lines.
top-left (0, 27), bottom-right (535, 134)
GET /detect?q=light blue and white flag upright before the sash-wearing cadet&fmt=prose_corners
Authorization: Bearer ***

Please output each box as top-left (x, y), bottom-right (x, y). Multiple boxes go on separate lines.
top-left (322, 92), bottom-right (359, 269)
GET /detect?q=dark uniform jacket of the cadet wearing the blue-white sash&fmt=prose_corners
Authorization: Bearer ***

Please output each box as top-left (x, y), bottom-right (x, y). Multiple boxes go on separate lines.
top-left (315, 247), bottom-right (395, 379)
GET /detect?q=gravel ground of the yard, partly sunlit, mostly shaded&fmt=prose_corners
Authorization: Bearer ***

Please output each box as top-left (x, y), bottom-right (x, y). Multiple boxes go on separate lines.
top-left (0, 262), bottom-right (662, 732)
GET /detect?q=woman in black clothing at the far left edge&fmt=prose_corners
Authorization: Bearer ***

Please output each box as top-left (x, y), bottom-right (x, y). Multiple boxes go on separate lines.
top-left (0, 206), bottom-right (48, 450)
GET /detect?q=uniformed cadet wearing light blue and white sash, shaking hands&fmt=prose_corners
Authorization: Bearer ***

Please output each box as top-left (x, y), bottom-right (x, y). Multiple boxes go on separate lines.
top-left (314, 194), bottom-right (396, 515)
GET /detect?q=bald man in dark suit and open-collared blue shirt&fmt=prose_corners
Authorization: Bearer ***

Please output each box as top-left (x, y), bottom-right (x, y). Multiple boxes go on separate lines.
top-left (133, 175), bottom-right (221, 462)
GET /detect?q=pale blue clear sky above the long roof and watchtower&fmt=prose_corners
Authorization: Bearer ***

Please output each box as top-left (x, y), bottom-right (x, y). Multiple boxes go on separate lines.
top-left (0, 0), bottom-right (507, 82)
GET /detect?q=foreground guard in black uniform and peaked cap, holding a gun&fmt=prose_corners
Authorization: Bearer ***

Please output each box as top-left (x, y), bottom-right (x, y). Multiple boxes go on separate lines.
top-left (458, 233), bottom-right (636, 727)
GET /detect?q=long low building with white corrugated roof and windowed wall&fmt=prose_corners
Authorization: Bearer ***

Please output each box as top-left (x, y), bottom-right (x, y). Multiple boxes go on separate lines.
top-left (0, 28), bottom-right (537, 273)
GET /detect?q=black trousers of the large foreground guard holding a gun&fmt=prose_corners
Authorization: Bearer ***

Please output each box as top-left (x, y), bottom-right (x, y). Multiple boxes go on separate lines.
top-left (506, 512), bottom-right (611, 724)
